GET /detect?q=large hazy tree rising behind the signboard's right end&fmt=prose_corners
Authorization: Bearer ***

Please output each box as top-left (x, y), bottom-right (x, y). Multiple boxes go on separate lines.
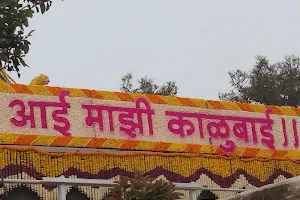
top-left (219, 55), bottom-right (300, 107)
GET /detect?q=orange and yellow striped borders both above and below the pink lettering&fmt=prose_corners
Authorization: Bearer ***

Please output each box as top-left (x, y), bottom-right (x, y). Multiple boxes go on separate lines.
top-left (0, 83), bottom-right (300, 160)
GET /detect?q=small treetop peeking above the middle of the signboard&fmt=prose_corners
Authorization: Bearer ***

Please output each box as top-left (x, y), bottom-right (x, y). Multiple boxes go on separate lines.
top-left (120, 73), bottom-right (178, 96)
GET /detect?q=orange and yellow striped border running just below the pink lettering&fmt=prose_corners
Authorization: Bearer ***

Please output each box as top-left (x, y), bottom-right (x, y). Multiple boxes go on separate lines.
top-left (0, 140), bottom-right (300, 163)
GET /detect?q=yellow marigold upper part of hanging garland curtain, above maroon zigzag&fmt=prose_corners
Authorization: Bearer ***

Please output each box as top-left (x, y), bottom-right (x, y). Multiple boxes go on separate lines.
top-left (0, 147), bottom-right (300, 182)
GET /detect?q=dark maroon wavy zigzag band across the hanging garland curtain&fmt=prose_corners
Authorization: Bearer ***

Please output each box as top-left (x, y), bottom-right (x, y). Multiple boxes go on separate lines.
top-left (2, 165), bottom-right (293, 191)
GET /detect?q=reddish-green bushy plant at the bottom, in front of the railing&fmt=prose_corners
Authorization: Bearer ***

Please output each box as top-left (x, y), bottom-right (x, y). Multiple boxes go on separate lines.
top-left (103, 173), bottom-right (183, 200)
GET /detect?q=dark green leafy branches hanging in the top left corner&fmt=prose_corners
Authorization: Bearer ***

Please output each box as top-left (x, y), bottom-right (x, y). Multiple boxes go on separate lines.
top-left (0, 0), bottom-right (52, 76)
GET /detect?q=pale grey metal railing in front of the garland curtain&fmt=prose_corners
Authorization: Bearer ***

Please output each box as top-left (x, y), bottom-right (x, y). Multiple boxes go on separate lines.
top-left (1, 176), bottom-right (247, 200)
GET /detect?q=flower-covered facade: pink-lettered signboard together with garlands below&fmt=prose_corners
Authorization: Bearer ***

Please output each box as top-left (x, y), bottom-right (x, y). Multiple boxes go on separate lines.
top-left (0, 84), bottom-right (300, 200)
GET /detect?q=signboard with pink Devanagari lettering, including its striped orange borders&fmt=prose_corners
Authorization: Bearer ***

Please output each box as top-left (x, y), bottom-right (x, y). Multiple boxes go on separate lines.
top-left (0, 84), bottom-right (300, 159)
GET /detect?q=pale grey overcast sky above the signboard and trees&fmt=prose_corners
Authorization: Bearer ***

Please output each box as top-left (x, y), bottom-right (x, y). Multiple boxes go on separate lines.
top-left (14, 0), bottom-right (300, 99)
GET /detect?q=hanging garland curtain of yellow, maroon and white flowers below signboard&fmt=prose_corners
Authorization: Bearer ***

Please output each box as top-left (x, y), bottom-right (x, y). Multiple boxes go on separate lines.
top-left (0, 146), bottom-right (300, 200)
